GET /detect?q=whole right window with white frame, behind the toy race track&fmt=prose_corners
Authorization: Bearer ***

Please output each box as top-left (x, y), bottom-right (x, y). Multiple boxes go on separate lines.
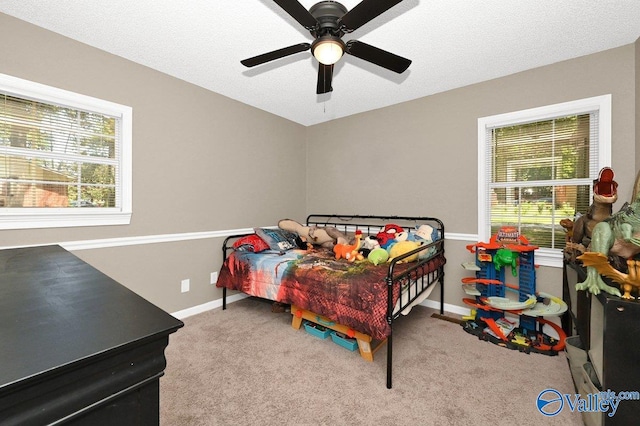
top-left (478, 95), bottom-right (611, 266)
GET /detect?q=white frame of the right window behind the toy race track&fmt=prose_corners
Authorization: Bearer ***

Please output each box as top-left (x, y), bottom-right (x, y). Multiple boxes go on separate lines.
top-left (478, 94), bottom-right (611, 267)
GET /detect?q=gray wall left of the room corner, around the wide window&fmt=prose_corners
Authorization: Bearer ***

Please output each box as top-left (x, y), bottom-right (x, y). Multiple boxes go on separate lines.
top-left (0, 14), bottom-right (306, 312)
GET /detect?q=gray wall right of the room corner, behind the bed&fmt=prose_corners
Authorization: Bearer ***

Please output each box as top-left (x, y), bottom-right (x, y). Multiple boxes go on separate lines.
top-left (307, 45), bottom-right (638, 305)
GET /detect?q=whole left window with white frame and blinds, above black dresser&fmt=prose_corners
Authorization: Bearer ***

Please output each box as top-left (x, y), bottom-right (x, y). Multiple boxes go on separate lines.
top-left (0, 74), bottom-right (132, 229)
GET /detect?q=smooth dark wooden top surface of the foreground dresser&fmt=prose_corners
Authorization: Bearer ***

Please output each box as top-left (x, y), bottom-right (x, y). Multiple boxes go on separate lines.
top-left (0, 246), bottom-right (184, 394)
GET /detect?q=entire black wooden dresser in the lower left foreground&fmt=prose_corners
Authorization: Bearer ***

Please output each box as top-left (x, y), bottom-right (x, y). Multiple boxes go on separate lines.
top-left (0, 246), bottom-right (184, 426)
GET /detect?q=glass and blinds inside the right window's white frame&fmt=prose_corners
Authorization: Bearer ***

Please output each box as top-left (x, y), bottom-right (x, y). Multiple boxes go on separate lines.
top-left (489, 113), bottom-right (597, 249)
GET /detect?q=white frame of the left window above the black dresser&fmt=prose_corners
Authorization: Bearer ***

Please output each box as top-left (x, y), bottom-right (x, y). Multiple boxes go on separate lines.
top-left (0, 74), bottom-right (133, 229)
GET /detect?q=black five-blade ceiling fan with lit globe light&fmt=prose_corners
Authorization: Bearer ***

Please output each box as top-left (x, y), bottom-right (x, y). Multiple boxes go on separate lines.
top-left (240, 0), bottom-right (411, 94)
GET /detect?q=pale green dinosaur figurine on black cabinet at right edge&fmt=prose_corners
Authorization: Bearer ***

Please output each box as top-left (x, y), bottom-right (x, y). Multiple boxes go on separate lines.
top-left (576, 167), bottom-right (640, 296)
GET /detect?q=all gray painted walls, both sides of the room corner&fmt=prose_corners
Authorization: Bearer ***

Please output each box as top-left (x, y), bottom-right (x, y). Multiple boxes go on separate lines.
top-left (0, 14), bottom-right (640, 312)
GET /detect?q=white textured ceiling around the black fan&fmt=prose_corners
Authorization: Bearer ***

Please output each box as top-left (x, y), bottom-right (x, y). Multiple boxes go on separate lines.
top-left (0, 0), bottom-right (640, 125)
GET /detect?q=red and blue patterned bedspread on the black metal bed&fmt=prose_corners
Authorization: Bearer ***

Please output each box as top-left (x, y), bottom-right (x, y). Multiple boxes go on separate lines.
top-left (217, 249), bottom-right (445, 340)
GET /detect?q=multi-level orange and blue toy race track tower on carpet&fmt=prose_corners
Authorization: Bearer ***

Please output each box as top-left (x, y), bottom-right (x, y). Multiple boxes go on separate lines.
top-left (462, 227), bottom-right (567, 355)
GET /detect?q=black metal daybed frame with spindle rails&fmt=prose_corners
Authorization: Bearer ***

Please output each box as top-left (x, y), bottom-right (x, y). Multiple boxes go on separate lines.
top-left (222, 214), bottom-right (445, 389)
